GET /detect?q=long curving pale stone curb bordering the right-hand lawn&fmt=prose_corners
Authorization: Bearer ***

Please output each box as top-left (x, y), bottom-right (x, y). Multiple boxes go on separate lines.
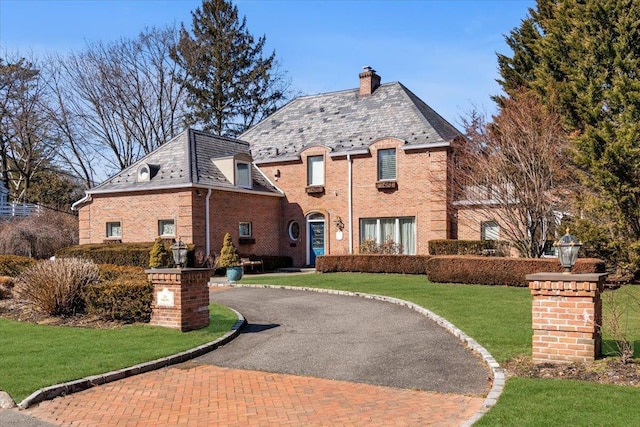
top-left (219, 283), bottom-right (505, 426)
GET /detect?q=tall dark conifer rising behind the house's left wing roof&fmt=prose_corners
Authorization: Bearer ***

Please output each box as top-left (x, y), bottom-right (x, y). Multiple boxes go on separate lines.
top-left (172, 0), bottom-right (287, 136)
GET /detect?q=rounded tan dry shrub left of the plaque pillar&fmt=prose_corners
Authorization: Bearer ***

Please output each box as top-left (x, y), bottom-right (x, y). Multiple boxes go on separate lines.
top-left (15, 258), bottom-right (100, 316)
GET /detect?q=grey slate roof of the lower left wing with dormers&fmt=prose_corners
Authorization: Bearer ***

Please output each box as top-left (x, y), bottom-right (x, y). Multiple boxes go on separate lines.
top-left (88, 129), bottom-right (280, 194)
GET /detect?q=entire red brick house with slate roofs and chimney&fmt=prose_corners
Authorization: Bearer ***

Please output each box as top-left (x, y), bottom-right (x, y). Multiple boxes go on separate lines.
top-left (75, 68), bottom-right (490, 266)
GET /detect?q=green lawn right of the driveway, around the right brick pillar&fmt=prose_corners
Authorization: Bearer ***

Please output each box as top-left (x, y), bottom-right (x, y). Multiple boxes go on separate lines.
top-left (241, 273), bottom-right (640, 426)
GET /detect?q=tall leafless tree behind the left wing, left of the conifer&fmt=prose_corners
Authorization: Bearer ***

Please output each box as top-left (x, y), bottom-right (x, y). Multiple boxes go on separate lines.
top-left (55, 28), bottom-right (186, 177)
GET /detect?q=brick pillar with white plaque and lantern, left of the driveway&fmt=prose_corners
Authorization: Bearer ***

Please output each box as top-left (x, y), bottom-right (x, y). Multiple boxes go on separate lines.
top-left (145, 268), bottom-right (211, 332)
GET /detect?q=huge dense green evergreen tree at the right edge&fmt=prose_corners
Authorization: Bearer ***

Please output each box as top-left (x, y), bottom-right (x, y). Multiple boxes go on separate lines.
top-left (496, 0), bottom-right (640, 269)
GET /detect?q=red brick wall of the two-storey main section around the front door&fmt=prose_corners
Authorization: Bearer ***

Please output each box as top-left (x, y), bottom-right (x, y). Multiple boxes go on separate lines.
top-left (260, 139), bottom-right (451, 265)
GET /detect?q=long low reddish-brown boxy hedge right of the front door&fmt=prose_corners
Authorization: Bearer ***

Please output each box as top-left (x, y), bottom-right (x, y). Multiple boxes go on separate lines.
top-left (316, 255), bottom-right (605, 286)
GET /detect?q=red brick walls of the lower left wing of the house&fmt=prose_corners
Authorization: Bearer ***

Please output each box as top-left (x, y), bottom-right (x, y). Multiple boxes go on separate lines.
top-left (79, 189), bottom-right (281, 255)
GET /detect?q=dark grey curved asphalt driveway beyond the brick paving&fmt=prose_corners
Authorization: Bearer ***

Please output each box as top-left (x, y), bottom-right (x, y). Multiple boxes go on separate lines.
top-left (200, 287), bottom-right (491, 396)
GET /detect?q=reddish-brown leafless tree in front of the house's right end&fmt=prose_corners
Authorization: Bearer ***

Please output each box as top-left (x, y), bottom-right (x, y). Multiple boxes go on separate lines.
top-left (455, 92), bottom-right (570, 258)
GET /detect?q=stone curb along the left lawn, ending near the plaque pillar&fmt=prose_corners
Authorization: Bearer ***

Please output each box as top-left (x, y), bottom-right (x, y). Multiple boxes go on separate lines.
top-left (18, 308), bottom-right (247, 409)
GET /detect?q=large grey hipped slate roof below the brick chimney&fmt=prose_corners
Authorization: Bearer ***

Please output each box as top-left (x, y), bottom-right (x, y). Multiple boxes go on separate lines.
top-left (240, 82), bottom-right (461, 163)
